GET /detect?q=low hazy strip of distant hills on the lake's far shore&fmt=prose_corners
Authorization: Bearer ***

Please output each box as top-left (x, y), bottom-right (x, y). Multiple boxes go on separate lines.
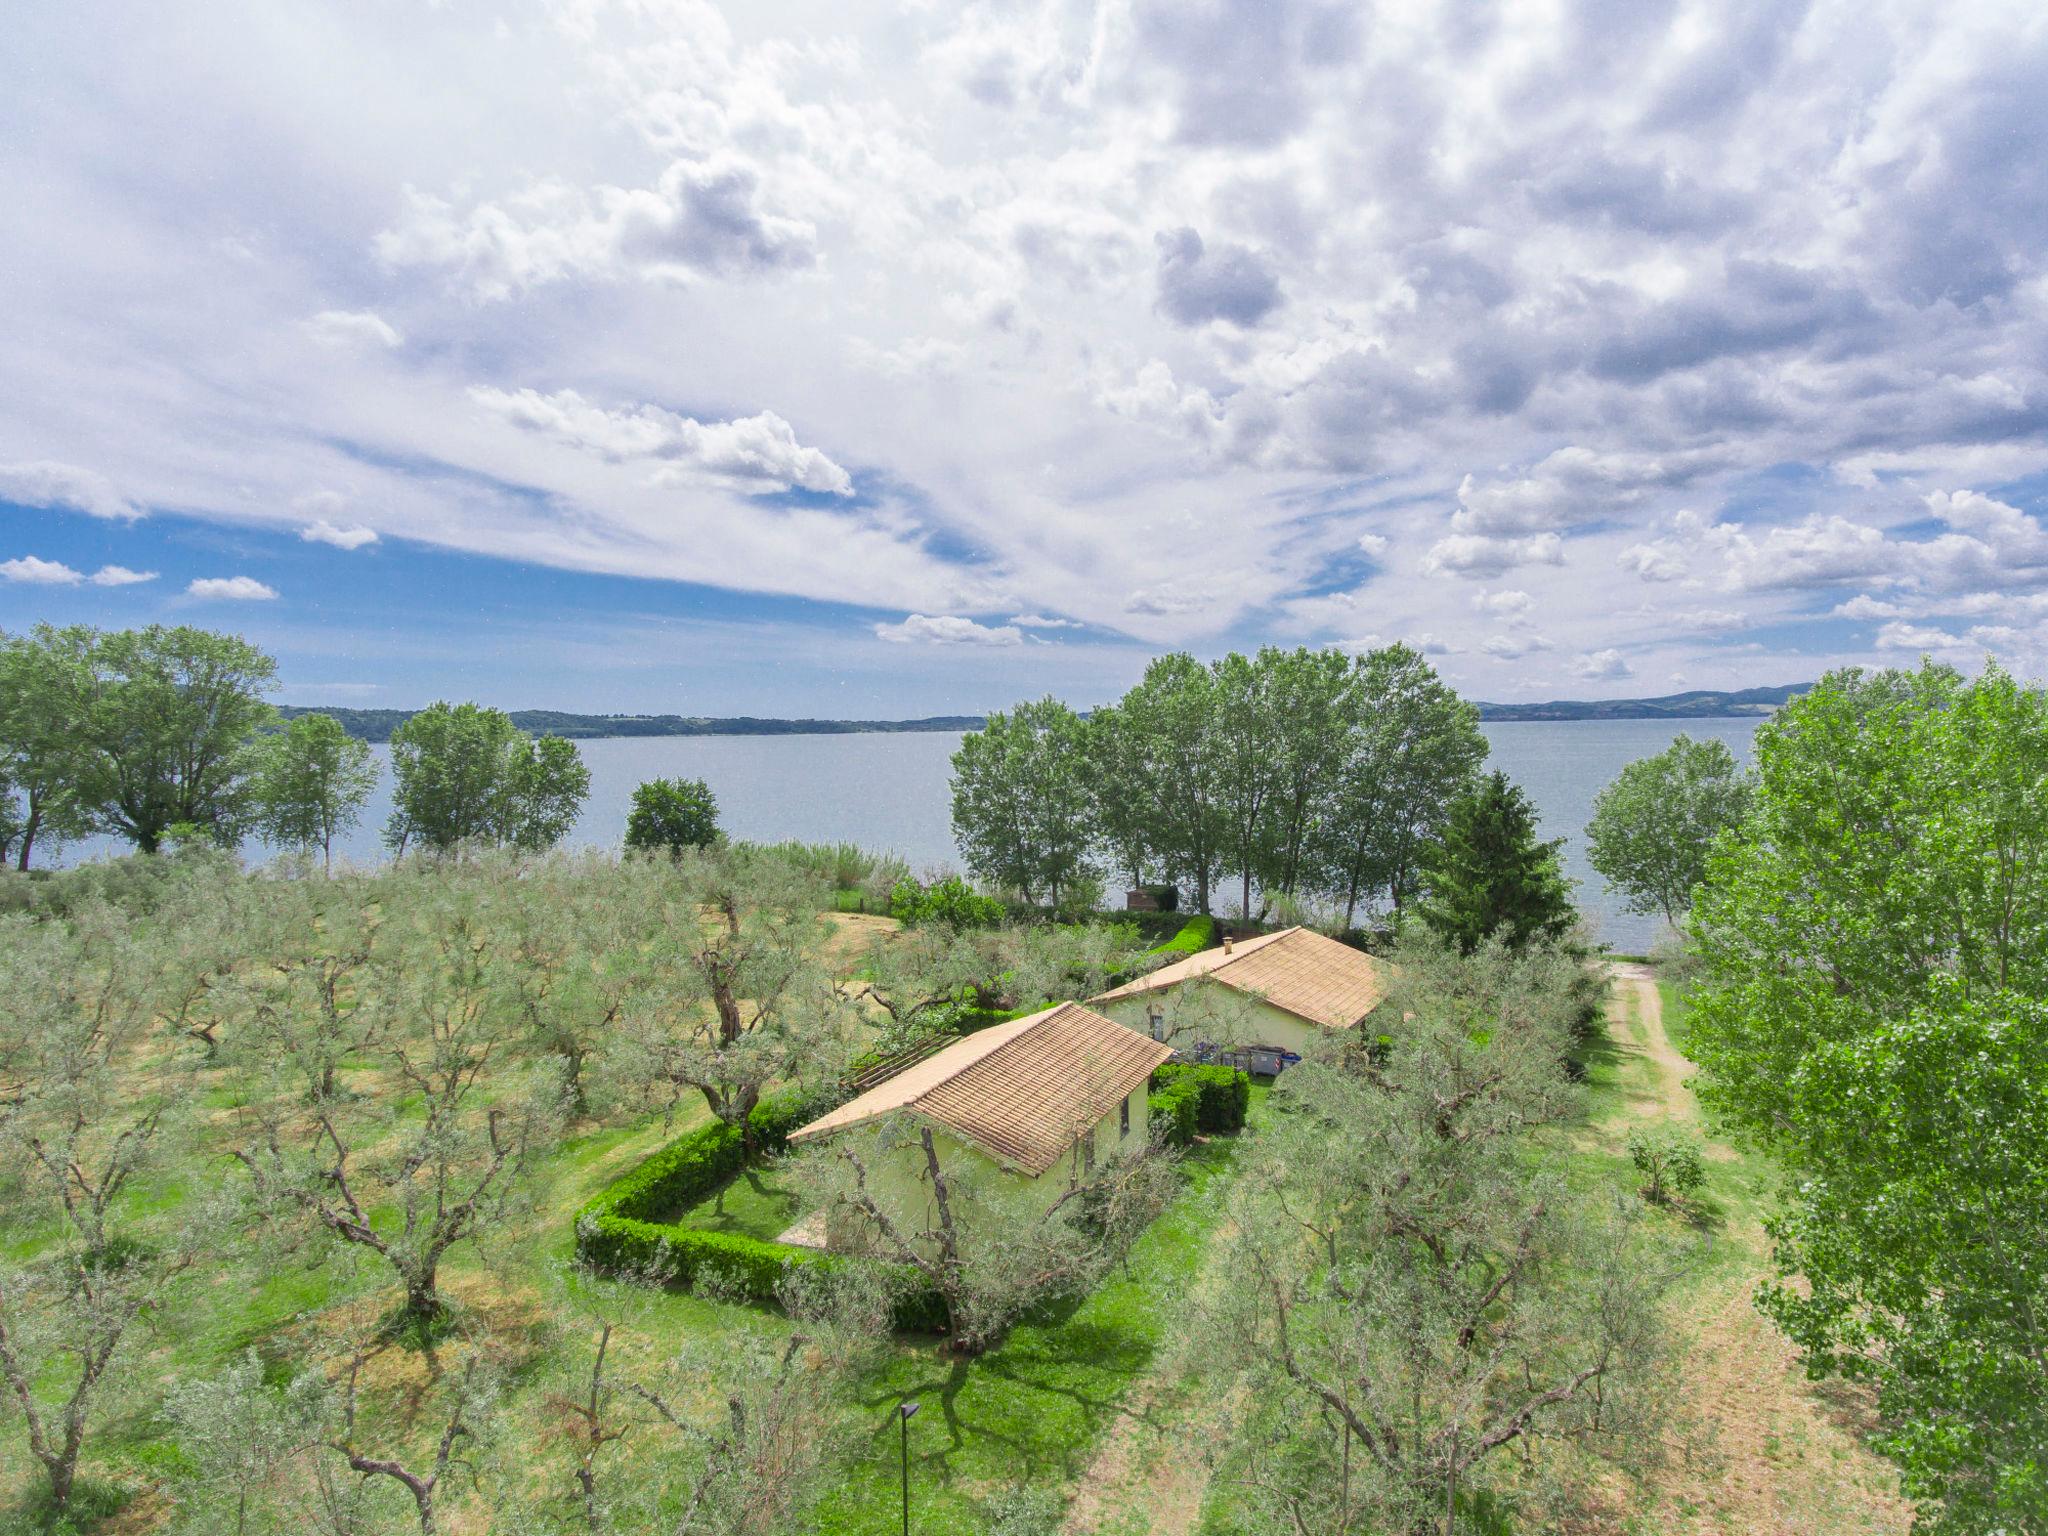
top-left (279, 682), bottom-right (1812, 741)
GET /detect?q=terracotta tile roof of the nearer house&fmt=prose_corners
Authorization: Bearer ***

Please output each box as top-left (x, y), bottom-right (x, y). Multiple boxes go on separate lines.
top-left (791, 1004), bottom-right (1174, 1178)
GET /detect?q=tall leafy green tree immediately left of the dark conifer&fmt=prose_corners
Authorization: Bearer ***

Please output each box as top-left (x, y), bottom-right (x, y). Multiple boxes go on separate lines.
top-left (1317, 645), bottom-right (1487, 924)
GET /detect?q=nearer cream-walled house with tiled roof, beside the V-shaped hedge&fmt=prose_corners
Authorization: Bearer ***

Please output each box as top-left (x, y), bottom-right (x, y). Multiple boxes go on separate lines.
top-left (791, 1004), bottom-right (1174, 1247)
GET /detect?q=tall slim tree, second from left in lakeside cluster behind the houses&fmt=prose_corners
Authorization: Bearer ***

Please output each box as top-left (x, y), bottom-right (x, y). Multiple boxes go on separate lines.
top-left (1116, 651), bottom-right (1231, 911)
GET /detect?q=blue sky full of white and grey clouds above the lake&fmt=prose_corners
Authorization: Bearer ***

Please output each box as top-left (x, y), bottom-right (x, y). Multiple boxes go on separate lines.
top-left (0, 0), bottom-right (2048, 717)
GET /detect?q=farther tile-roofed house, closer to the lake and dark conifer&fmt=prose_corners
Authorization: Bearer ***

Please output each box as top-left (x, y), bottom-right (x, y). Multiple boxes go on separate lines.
top-left (1090, 928), bottom-right (1386, 1075)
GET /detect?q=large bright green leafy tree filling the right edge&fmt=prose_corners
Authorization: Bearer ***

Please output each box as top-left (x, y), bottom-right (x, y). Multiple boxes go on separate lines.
top-left (1688, 664), bottom-right (2048, 1532)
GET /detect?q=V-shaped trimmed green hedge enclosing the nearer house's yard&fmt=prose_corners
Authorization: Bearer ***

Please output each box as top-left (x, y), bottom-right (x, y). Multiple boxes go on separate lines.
top-left (575, 1094), bottom-right (946, 1333)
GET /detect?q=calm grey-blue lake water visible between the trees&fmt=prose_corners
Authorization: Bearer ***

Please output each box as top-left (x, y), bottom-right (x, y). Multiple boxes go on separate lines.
top-left (63, 719), bottom-right (1757, 950)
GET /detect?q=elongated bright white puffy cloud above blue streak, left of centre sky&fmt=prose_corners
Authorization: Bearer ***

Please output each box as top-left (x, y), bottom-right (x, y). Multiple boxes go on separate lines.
top-left (469, 387), bottom-right (854, 496)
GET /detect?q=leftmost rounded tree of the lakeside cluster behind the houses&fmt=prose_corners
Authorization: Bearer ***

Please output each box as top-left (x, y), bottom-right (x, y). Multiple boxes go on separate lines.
top-left (952, 698), bottom-right (1094, 909)
